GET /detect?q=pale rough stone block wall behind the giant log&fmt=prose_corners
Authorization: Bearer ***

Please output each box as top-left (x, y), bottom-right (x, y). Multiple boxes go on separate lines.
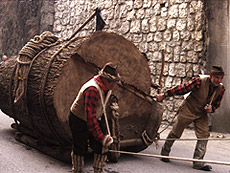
top-left (54, 0), bottom-right (206, 120)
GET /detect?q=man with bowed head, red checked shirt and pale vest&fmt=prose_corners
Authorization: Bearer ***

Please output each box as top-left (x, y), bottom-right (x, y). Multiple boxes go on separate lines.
top-left (69, 62), bottom-right (120, 173)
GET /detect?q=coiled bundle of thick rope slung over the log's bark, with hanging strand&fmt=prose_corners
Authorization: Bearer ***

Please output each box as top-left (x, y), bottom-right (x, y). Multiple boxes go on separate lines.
top-left (10, 32), bottom-right (59, 145)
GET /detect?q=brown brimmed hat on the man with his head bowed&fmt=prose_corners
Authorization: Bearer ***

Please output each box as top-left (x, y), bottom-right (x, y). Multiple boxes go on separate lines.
top-left (99, 62), bottom-right (121, 82)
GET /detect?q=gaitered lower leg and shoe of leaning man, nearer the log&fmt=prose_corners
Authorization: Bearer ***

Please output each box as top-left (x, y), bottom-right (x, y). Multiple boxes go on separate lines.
top-left (161, 132), bottom-right (178, 162)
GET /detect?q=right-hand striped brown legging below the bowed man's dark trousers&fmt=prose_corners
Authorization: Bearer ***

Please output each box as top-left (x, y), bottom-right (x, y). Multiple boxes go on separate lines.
top-left (93, 153), bottom-right (107, 173)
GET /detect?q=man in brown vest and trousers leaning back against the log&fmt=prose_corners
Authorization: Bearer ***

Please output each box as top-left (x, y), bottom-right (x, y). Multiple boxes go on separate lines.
top-left (157, 66), bottom-right (225, 171)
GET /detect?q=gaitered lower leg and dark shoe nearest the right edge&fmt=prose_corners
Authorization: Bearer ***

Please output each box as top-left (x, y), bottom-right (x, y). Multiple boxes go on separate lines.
top-left (193, 140), bottom-right (212, 171)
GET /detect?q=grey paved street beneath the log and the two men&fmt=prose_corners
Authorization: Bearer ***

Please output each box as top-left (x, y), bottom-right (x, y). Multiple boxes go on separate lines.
top-left (0, 112), bottom-right (230, 173)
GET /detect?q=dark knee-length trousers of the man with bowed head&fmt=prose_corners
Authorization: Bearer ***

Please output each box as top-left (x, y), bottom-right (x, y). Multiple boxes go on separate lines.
top-left (69, 111), bottom-right (105, 156)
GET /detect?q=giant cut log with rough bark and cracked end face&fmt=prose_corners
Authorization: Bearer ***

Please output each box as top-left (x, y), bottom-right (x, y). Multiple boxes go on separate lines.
top-left (0, 31), bottom-right (163, 162)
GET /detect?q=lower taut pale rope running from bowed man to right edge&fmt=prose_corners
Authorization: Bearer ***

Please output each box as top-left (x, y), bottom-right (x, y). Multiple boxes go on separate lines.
top-left (109, 150), bottom-right (230, 166)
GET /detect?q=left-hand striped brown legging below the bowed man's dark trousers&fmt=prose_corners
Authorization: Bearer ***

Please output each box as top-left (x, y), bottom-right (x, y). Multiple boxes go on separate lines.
top-left (71, 151), bottom-right (84, 173)
